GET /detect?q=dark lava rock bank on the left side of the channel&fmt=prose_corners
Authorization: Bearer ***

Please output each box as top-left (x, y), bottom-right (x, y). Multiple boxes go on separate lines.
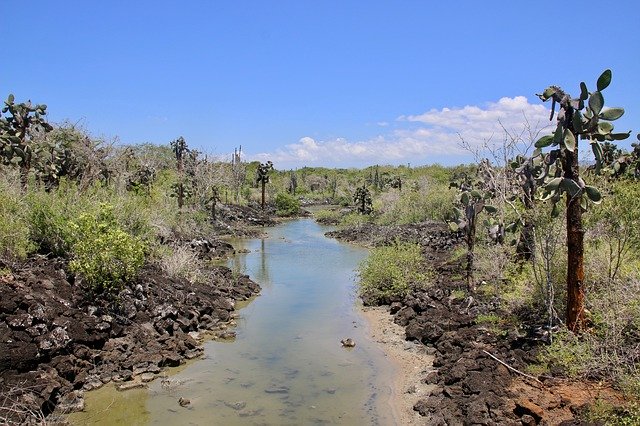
top-left (0, 248), bottom-right (260, 423)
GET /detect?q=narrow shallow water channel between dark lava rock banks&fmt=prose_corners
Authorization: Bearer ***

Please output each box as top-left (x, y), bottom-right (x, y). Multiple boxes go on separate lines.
top-left (67, 219), bottom-right (394, 425)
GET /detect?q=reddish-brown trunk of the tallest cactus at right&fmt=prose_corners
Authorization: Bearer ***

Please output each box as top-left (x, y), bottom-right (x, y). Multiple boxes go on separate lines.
top-left (564, 142), bottom-right (585, 331)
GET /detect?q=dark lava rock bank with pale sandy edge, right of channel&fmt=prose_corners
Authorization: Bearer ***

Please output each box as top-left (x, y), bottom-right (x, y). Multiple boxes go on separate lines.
top-left (330, 222), bottom-right (622, 425)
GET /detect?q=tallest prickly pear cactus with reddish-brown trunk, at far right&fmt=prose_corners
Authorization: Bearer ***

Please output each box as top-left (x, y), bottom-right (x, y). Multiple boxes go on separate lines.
top-left (536, 70), bottom-right (631, 331)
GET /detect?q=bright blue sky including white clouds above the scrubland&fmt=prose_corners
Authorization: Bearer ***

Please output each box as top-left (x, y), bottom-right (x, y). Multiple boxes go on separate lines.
top-left (0, 0), bottom-right (640, 168)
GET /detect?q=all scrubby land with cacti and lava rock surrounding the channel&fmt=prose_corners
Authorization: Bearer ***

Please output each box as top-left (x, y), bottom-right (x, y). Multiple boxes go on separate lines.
top-left (0, 71), bottom-right (640, 424)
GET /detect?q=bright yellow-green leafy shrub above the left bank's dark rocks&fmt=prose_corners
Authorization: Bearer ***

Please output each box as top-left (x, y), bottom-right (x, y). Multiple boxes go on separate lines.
top-left (69, 204), bottom-right (145, 295)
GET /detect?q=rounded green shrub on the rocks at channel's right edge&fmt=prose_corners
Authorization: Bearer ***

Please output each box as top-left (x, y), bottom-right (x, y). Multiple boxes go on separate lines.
top-left (358, 241), bottom-right (428, 305)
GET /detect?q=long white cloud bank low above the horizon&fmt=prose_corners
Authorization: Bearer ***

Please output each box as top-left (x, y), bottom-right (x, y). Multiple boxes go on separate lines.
top-left (250, 96), bottom-right (549, 167)
